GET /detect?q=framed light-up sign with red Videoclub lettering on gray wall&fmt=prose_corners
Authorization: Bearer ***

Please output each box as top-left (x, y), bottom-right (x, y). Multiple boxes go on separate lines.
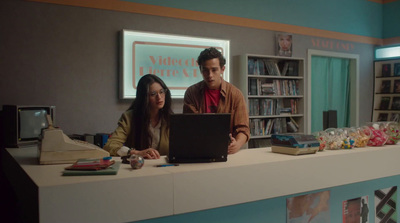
top-left (120, 30), bottom-right (229, 99)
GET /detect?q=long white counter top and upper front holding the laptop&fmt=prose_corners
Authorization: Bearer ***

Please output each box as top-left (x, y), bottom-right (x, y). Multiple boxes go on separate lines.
top-left (2, 145), bottom-right (400, 222)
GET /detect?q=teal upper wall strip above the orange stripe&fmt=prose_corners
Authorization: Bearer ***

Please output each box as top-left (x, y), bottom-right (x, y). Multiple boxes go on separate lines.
top-left (125, 0), bottom-right (384, 38)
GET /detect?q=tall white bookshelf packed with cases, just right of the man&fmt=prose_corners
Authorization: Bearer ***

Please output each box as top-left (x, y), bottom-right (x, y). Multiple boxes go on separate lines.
top-left (232, 54), bottom-right (306, 148)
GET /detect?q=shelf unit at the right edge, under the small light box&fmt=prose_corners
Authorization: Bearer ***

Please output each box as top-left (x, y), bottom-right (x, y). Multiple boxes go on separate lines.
top-left (372, 59), bottom-right (400, 122)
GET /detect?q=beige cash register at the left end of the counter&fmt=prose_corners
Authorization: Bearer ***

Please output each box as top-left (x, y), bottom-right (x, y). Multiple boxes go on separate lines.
top-left (39, 116), bottom-right (110, 164)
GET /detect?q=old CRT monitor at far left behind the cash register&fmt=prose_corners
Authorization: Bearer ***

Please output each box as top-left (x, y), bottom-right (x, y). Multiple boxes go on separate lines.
top-left (2, 105), bottom-right (56, 148)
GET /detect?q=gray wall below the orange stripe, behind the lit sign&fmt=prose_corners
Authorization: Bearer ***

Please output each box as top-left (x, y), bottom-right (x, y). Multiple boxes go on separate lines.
top-left (0, 0), bottom-right (373, 134)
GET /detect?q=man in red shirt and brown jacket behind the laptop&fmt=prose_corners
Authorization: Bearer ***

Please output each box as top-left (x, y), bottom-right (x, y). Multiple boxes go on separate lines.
top-left (183, 48), bottom-right (250, 154)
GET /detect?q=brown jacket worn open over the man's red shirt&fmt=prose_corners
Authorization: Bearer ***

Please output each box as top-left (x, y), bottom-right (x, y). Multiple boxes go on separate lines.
top-left (183, 80), bottom-right (250, 141)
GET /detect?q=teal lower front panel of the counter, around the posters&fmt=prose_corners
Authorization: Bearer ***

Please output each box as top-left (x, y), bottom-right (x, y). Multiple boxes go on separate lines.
top-left (135, 175), bottom-right (400, 223)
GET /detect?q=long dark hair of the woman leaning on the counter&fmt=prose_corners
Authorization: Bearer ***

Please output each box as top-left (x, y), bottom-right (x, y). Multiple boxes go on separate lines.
top-left (127, 74), bottom-right (172, 150)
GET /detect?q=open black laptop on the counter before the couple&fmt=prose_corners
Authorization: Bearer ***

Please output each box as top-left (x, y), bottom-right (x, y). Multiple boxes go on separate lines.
top-left (167, 113), bottom-right (231, 163)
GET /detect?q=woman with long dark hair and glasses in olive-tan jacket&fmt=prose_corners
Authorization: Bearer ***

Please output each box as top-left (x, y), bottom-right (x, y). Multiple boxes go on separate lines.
top-left (104, 74), bottom-right (172, 159)
